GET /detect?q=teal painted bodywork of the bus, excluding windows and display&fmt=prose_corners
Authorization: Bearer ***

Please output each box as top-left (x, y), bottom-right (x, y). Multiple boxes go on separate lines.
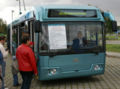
top-left (9, 6), bottom-right (113, 80)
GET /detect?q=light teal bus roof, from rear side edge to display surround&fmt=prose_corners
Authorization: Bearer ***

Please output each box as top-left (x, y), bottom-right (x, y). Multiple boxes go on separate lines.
top-left (12, 5), bottom-right (104, 25)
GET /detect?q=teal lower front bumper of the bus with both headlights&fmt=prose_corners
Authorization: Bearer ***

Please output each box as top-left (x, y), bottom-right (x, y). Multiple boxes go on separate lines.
top-left (38, 64), bottom-right (104, 80)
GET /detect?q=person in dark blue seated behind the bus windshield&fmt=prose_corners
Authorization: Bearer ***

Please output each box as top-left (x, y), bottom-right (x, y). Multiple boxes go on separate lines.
top-left (72, 31), bottom-right (87, 50)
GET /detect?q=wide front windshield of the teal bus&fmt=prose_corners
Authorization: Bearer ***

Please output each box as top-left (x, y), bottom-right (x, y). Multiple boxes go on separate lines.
top-left (39, 22), bottom-right (103, 54)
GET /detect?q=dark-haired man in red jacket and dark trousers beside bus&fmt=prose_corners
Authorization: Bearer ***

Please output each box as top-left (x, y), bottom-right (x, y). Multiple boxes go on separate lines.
top-left (16, 36), bottom-right (38, 89)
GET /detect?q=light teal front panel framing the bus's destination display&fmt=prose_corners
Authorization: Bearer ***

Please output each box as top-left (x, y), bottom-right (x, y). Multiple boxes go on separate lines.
top-left (34, 5), bottom-right (104, 22)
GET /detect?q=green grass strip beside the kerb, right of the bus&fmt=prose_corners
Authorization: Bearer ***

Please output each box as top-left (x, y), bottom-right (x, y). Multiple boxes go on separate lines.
top-left (106, 44), bottom-right (120, 53)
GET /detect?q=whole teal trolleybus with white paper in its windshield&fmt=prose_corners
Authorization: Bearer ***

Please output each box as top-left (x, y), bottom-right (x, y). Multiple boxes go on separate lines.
top-left (8, 5), bottom-right (116, 80)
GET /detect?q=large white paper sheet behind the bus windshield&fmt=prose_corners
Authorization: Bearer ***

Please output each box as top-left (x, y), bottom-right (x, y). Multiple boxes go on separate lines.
top-left (48, 24), bottom-right (67, 49)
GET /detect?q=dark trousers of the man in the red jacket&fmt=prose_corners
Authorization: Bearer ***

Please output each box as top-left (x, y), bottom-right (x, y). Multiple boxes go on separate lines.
top-left (20, 71), bottom-right (33, 89)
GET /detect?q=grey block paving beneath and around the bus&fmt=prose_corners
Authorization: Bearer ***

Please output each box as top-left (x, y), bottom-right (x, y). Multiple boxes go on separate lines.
top-left (0, 57), bottom-right (120, 89)
